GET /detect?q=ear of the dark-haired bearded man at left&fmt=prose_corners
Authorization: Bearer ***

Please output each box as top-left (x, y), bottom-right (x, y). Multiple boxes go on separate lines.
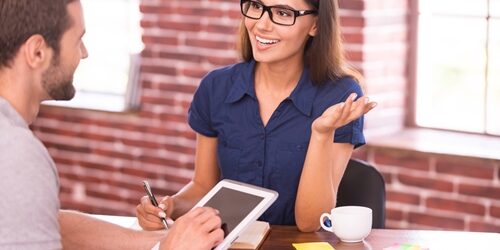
top-left (22, 35), bottom-right (52, 68)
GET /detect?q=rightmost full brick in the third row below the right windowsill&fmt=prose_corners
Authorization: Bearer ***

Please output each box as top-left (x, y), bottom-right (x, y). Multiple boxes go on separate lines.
top-left (425, 197), bottom-right (486, 215)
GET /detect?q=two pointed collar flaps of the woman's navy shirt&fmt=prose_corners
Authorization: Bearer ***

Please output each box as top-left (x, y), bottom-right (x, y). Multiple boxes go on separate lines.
top-left (225, 60), bottom-right (317, 116)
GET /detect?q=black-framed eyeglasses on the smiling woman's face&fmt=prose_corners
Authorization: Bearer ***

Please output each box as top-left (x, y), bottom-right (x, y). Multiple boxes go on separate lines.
top-left (240, 0), bottom-right (318, 26)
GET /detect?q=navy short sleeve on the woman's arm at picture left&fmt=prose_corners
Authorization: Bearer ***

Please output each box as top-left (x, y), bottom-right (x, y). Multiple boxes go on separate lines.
top-left (188, 75), bottom-right (217, 137)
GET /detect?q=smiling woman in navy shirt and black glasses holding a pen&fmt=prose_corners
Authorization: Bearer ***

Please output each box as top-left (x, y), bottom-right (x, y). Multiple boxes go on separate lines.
top-left (137, 0), bottom-right (375, 232)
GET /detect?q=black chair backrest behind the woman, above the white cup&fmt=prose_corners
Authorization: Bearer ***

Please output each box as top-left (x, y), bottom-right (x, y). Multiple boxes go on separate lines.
top-left (337, 159), bottom-right (385, 228)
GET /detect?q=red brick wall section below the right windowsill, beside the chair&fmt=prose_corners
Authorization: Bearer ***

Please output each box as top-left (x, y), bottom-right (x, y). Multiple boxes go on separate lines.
top-left (357, 146), bottom-right (500, 232)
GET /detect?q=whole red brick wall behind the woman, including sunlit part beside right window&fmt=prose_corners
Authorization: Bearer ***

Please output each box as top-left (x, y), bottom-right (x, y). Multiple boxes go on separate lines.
top-left (33, 0), bottom-right (500, 231)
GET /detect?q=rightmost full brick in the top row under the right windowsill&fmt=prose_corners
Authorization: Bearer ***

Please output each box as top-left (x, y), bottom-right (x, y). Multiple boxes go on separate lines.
top-left (436, 159), bottom-right (494, 180)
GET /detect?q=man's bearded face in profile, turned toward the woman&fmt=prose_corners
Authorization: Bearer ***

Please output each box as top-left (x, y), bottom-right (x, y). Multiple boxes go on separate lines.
top-left (42, 1), bottom-right (88, 100)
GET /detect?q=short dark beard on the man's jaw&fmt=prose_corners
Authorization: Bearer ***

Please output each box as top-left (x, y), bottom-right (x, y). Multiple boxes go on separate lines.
top-left (42, 56), bottom-right (75, 101)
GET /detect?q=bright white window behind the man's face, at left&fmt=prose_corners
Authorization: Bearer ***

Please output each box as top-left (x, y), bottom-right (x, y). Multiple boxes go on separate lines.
top-left (48, 0), bottom-right (143, 111)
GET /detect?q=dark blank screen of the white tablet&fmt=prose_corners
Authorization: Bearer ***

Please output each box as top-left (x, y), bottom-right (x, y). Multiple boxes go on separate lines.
top-left (205, 187), bottom-right (264, 236)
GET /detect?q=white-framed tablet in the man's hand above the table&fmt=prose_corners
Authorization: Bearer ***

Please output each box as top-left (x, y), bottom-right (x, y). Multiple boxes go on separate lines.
top-left (194, 180), bottom-right (278, 250)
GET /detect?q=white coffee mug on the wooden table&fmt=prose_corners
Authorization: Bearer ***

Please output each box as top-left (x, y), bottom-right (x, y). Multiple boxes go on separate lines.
top-left (319, 206), bottom-right (372, 242)
